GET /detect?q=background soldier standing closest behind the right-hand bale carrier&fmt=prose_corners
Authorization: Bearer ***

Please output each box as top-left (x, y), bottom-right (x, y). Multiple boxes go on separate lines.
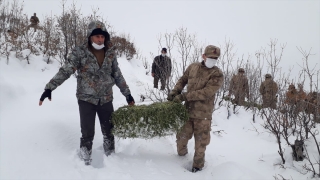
top-left (228, 68), bottom-right (249, 106)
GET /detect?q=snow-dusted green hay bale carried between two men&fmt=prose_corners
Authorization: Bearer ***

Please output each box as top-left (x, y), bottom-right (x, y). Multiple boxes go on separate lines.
top-left (112, 102), bottom-right (188, 139)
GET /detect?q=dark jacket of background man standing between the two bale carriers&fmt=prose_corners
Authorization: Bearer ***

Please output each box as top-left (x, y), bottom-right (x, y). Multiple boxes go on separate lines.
top-left (151, 55), bottom-right (172, 77)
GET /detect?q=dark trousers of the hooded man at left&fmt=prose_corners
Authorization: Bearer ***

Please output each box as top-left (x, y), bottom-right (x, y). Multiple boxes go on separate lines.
top-left (78, 100), bottom-right (114, 151)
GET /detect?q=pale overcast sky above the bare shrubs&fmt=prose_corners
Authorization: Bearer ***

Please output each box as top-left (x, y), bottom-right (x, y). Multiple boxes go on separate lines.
top-left (16, 0), bottom-right (320, 85)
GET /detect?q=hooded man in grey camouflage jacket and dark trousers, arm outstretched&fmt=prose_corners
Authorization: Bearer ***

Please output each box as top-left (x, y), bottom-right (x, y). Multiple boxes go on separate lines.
top-left (39, 21), bottom-right (135, 165)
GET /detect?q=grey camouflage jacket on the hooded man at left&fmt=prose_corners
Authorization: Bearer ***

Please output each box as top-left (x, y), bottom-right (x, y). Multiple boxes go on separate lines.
top-left (45, 45), bottom-right (130, 105)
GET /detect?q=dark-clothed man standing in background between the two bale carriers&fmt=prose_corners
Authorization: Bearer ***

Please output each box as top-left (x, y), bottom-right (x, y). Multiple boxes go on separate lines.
top-left (151, 48), bottom-right (172, 90)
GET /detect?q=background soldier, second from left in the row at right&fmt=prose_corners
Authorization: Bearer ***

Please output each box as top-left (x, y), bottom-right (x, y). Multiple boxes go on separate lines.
top-left (260, 74), bottom-right (278, 109)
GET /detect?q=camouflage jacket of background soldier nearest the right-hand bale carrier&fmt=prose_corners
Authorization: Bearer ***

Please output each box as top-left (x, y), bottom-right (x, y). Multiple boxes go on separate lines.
top-left (229, 74), bottom-right (249, 96)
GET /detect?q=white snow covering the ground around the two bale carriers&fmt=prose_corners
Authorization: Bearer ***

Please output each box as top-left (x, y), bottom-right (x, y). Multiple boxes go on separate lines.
top-left (0, 56), bottom-right (320, 180)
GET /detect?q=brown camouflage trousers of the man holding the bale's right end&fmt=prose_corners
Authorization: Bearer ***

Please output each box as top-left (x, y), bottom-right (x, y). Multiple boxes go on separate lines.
top-left (176, 118), bottom-right (211, 168)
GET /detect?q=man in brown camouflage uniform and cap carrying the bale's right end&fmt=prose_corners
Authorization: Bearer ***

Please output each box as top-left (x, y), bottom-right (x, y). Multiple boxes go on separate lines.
top-left (167, 45), bottom-right (223, 172)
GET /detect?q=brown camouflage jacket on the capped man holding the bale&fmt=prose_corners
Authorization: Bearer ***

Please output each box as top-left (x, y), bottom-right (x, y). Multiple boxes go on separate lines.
top-left (174, 62), bottom-right (223, 120)
